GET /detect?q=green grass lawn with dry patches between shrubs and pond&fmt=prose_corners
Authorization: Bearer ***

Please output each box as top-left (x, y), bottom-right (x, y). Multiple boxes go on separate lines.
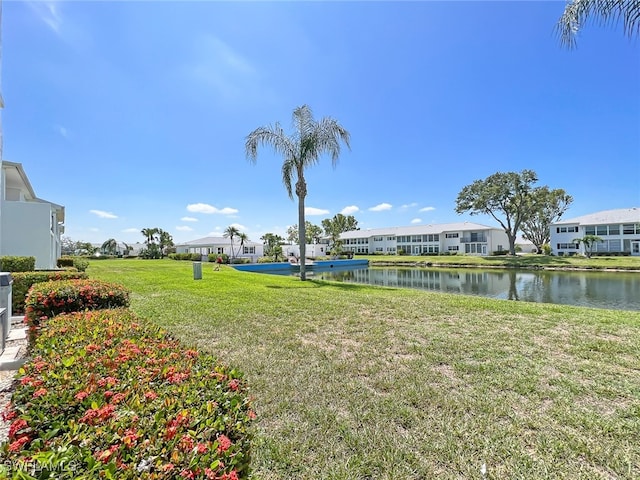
top-left (87, 257), bottom-right (640, 480)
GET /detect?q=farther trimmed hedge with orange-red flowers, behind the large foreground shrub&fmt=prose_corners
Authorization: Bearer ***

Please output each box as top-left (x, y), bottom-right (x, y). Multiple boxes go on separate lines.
top-left (25, 280), bottom-right (129, 346)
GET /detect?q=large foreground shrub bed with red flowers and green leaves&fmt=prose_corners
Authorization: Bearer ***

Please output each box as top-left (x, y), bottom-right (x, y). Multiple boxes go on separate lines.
top-left (0, 309), bottom-right (255, 480)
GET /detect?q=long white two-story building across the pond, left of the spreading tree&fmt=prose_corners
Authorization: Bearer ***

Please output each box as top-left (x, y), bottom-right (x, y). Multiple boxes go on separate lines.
top-left (340, 222), bottom-right (509, 255)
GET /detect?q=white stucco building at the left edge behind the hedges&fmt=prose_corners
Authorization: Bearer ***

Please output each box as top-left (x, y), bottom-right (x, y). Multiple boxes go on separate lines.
top-left (0, 161), bottom-right (64, 269)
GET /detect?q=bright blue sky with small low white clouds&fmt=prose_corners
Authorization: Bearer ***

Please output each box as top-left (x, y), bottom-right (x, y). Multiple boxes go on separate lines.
top-left (2, 1), bottom-right (640, 243)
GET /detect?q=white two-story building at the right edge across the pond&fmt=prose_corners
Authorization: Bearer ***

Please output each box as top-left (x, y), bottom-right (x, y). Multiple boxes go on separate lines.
top-left (550, 207), bottom-right (640, 255)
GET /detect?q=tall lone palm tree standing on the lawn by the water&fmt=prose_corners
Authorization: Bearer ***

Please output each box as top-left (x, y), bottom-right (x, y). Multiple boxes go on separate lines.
top-left (245, 105), bottom-right (351, 281)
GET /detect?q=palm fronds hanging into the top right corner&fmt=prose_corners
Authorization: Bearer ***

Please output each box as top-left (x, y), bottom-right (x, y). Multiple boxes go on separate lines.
top-left (556, 0), bottom-right (640, 48)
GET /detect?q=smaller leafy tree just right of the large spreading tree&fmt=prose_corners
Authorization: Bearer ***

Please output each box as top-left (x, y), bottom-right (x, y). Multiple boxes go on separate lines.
top-left (521, 187), bottom-right (573, 253)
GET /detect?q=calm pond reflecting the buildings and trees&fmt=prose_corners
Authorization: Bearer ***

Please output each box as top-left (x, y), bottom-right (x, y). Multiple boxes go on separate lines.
top-left (309, 267), bottom-right (640, 311)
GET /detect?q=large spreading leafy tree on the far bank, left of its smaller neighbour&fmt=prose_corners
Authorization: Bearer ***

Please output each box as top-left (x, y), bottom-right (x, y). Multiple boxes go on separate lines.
top-left (456, 170), bottom-right (538, 255)
